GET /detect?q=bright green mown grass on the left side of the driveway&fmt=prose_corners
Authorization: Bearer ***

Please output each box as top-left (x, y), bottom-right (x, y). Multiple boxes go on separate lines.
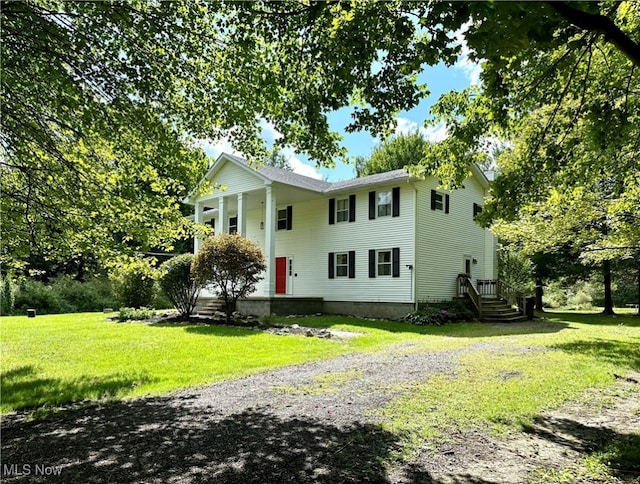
top-left (0, 313), bottom-right (444, 413)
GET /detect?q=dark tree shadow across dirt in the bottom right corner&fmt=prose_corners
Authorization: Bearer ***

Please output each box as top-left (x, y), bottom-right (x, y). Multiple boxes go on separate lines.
top-left (524, 417), bottom-right (640, 482)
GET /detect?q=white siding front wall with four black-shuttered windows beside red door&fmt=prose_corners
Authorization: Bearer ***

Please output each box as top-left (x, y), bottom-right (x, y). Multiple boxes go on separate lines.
top-left (247, 183), bottom-right (414, 302)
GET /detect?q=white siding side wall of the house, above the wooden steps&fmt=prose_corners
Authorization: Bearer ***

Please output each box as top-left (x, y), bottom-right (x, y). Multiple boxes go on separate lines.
top-left (416, 178), bottom-right (495, 301)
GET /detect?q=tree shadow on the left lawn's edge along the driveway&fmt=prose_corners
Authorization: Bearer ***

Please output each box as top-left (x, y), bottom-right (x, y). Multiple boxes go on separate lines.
top-left (0, 366), bottom-right (151, 409)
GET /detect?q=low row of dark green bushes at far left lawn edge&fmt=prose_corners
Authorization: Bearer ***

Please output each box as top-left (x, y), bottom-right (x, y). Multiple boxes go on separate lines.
top-left (15, 275), bottom-right (116, 314)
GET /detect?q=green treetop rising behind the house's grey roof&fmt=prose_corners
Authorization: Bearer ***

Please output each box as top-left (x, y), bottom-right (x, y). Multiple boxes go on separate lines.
top-left (356, 131), bottom-right (430, 177)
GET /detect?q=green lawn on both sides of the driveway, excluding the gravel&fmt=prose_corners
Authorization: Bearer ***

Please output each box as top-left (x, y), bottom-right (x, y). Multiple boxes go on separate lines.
top-left (0, 312), bottom-right (640, 424)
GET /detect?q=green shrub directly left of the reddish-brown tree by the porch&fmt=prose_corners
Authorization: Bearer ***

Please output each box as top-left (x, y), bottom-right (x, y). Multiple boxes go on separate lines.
top-left (158, 254), bottom-right (201, 317)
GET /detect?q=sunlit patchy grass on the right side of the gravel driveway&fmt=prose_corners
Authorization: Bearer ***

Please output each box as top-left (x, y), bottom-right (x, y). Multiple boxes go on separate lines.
top-left (381, 311), bottom-right (640, 482)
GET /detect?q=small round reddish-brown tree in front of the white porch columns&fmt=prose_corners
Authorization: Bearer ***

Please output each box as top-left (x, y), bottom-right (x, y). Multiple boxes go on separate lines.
top-left (191, 233), bottom-right (266, 323)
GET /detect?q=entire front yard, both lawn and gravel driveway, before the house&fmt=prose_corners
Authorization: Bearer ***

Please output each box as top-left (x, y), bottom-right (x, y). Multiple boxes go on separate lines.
top-left (1, 311), bottom-right (640, 483)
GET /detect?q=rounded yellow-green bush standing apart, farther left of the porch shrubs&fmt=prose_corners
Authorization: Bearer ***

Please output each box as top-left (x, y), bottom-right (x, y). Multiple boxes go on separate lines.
top-left (111, 258), bottom-right (156, 308)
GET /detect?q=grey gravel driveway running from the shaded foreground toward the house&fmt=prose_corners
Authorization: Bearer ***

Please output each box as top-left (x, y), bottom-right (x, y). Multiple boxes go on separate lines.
top-left (2, 334), bottom-right (640, 483)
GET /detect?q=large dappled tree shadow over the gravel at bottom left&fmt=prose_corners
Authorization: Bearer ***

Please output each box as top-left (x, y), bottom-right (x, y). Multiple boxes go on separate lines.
top-left (2, 397), bottom-right (484, 484)
